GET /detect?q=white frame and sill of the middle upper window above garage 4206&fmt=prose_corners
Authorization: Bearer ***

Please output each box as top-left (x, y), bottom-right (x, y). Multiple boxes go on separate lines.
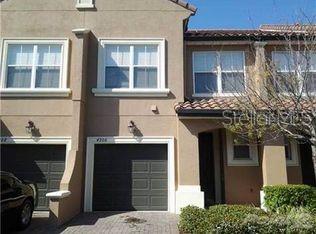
top-left (92, 38), bottom-right (169, 96)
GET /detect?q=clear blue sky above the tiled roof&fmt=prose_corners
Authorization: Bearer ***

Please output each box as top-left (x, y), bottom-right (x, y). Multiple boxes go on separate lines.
top-left (187, 0), bottom-right (316, 29)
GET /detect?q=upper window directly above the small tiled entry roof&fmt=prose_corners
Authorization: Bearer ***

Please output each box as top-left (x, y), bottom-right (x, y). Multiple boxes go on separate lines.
top-left (193, 51), bottom-right (245, 96)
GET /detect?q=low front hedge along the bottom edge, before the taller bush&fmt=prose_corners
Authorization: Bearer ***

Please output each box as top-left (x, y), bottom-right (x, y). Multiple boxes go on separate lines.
top-left (178, 205), bottom-right (316, 234)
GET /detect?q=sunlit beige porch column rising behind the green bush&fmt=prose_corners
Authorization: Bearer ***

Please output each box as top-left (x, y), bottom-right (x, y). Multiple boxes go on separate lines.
top-left (262, 145), bottom-right (287, 186)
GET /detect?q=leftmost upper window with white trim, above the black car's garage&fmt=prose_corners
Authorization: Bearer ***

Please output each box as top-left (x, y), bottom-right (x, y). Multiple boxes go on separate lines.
top-left (1, 40), bottom-right (69, 95)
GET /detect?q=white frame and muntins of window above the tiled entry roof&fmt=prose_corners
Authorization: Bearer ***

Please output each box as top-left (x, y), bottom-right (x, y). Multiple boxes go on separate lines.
top-left (192, 50), bottom-right (247, 97)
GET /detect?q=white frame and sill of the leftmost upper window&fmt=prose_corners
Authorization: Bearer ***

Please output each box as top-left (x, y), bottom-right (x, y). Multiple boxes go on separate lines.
top-left (0, 38), bottom-right (70, 96)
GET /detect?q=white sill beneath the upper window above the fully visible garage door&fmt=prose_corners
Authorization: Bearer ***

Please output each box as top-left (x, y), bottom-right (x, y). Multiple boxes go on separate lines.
top-left (92, 89), bottom-right (170, 97)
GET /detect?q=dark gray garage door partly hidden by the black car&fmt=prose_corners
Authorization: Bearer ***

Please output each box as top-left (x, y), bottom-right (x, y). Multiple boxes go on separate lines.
top-left (1, 144), bottom-right (66, 210)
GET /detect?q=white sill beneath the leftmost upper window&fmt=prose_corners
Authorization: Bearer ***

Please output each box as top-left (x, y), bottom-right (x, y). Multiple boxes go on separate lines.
top-left (0, 89), bottom-right (71, 97)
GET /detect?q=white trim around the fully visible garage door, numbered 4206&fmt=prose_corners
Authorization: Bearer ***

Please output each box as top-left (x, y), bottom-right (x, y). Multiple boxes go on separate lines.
top-left (84, 137), bottom-right (175, 213)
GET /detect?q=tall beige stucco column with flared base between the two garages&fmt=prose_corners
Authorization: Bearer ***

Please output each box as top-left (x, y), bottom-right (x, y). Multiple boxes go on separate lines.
top-left (50, 29), bottom-right (90, 225)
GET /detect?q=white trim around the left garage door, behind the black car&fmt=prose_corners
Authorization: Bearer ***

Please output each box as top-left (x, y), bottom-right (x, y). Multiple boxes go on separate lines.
top-left (0, 136), bottom-right (71, 178)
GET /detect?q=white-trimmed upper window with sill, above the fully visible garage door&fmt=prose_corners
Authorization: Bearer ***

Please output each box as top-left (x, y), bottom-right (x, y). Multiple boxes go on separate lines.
top-left (93, 40), bottom-right (169, 96)
